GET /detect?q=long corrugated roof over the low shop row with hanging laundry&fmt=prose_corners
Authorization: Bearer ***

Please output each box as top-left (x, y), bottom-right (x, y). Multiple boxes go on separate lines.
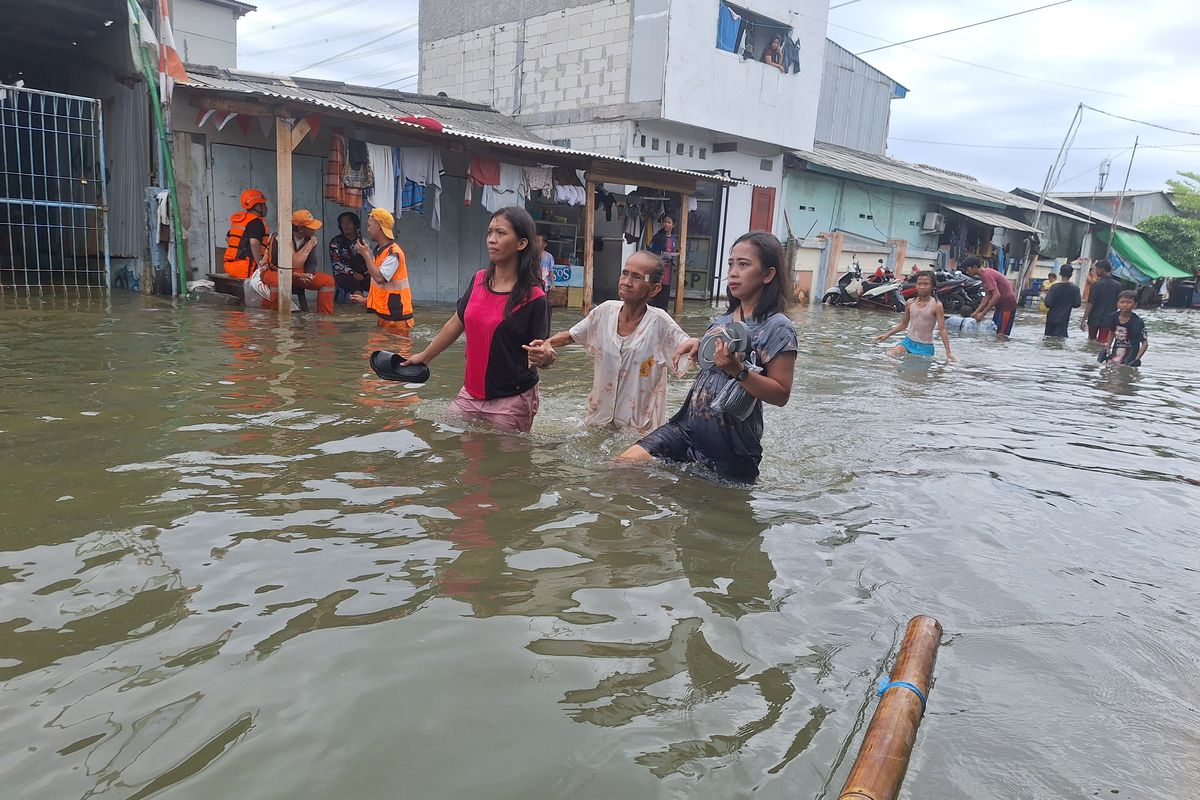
top-left (180, 65), bottom-right (738, 186)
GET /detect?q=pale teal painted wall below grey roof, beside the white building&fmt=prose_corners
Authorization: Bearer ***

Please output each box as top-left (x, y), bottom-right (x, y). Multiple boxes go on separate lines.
top-left (784, 169), bottom-right (938, 249)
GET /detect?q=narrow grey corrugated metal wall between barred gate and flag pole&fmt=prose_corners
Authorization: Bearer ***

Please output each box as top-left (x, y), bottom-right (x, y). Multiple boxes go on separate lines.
top-left (104, 82), bottom-right (152, 258)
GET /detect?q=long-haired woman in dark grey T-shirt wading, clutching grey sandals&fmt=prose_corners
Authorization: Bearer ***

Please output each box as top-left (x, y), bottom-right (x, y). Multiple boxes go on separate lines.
top-left (618, 231), bottom-right (797, 483)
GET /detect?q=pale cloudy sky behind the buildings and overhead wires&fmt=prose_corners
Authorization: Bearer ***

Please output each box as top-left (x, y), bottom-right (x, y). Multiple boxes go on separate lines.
top-left (229, 0), bottom-right (1200, 191)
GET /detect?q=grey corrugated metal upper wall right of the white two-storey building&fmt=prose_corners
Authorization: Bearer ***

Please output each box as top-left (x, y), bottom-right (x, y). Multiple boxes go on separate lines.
top-left (816, 42), bottom-right (895, 156)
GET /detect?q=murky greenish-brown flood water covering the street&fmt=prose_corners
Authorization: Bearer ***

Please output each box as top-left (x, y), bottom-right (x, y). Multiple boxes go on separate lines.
top-left (0, 293), bottom-right (1200, 800)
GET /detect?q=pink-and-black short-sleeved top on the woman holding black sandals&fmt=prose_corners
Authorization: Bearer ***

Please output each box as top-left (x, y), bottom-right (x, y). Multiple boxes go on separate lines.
top-left (458, 270), bottom-right (550, 401)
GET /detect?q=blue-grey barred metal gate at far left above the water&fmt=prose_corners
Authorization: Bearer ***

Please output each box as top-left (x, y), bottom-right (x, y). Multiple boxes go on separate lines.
top-left (0, 84), bottom-right (109, 291)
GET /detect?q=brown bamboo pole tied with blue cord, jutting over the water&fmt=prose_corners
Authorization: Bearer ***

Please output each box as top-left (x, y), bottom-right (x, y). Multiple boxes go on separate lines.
top-left (838, 615), bottom-right (942, 800)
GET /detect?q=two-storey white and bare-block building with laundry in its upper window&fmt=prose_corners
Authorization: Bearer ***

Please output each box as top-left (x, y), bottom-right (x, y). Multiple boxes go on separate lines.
top-left (419, 0), bottom-right (828, 299)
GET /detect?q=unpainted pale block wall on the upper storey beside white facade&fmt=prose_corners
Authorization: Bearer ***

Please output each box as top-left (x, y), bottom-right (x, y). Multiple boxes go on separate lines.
top-left (420, 0), bottom-right (631, 115)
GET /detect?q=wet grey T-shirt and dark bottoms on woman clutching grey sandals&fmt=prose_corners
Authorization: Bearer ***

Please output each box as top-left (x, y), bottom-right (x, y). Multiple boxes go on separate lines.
top-left (638, 313), bottom-right (797, 482)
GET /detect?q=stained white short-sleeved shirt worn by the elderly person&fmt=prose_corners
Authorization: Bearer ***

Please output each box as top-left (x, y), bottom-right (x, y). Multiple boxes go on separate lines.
top-left (570, 300), bottom-right (689, 433)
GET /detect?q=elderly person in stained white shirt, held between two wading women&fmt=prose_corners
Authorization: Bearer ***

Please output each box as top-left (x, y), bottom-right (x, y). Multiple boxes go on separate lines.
top-left (526, 251), bottom-right (689, 433)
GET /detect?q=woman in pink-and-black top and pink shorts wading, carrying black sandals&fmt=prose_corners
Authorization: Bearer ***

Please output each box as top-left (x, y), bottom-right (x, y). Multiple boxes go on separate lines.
top-left (408, 206), bottom-right (550, 431)
